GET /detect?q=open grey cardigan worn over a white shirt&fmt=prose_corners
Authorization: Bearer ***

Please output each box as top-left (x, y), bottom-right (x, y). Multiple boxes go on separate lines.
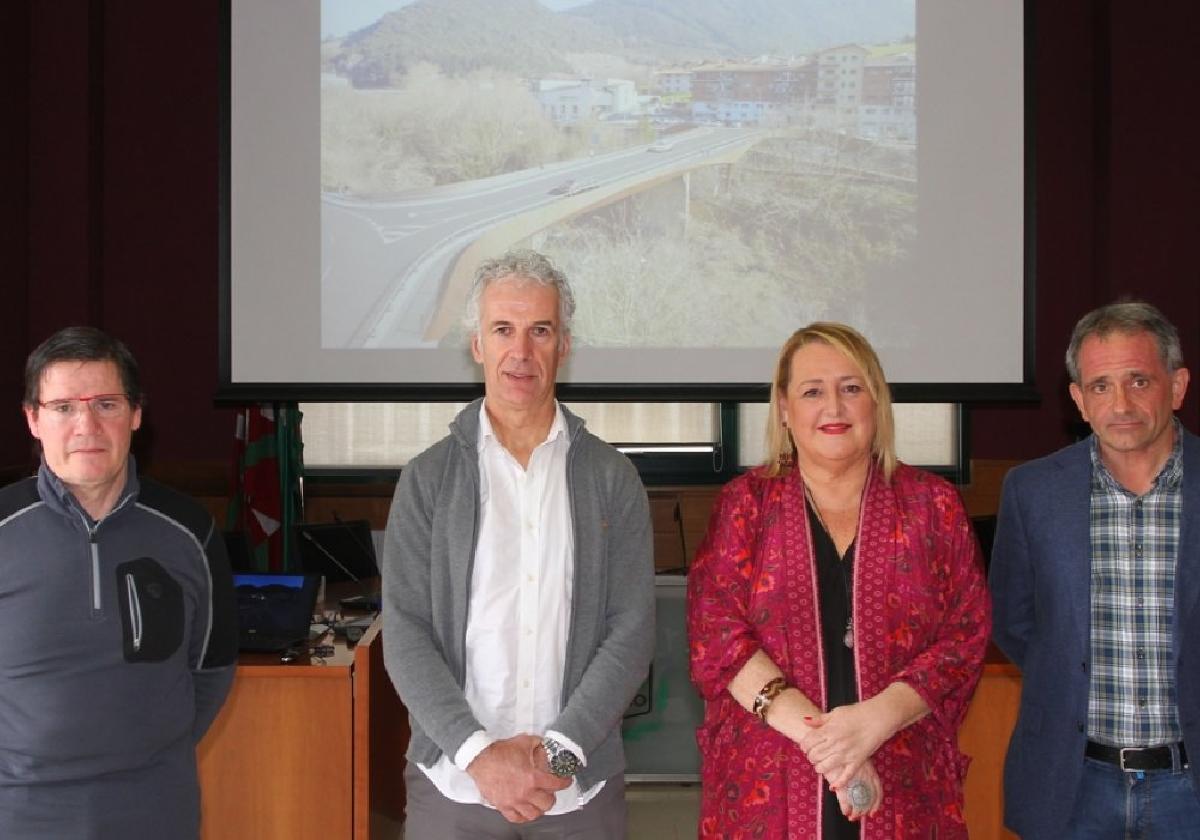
top-left (383, 400), bottom-right (654, 790)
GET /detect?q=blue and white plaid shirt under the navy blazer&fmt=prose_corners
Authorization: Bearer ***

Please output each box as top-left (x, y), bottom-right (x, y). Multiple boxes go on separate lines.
top-left (1087, 420), bottom-right (1183, 746)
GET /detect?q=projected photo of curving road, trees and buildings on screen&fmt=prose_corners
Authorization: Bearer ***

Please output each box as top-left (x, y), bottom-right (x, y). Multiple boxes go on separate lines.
top-left (320, 0), bottom-right (918, 349)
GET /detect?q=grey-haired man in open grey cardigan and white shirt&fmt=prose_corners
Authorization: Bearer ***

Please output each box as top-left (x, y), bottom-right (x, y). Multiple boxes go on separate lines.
top-left (383, 251), bottom-right (654, 840)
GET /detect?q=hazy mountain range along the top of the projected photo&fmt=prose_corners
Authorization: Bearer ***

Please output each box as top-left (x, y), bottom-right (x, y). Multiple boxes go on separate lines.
top-left (323, 0), bottom-right (914, 88)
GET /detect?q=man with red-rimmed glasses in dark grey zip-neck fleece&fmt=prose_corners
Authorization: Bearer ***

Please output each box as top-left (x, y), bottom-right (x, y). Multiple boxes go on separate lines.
top-left (0, 326), bottom-right (238, 840)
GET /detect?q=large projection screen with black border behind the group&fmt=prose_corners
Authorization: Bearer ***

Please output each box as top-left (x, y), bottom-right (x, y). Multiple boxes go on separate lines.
top-left (218, 0), bottom-right (1033, 401)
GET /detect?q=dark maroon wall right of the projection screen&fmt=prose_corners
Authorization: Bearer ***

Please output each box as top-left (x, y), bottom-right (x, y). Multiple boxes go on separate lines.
top-left (971, 0), bottom-right (1200, 458)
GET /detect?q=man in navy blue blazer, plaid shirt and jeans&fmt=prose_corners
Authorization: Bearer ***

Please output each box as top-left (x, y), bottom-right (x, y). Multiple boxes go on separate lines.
top-left (990, 302), bottom-right (1200, 840)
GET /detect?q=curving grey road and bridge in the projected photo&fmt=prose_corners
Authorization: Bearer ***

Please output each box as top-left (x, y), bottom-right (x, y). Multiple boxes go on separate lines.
top-left (322, 127), bottom-right (760, 347)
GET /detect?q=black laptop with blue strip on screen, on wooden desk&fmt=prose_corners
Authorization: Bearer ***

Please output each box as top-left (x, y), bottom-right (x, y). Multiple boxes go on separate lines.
top-left (233, 572), bottom-right (320, 653)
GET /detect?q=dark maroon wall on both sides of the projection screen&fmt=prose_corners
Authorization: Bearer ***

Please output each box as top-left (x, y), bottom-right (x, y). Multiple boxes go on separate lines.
top-left (0, 0), bottom-right (1200, 467)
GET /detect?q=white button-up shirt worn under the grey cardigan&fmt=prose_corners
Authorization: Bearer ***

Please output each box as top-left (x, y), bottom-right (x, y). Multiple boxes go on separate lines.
top-left (421, 400), bottom-right (604, 814)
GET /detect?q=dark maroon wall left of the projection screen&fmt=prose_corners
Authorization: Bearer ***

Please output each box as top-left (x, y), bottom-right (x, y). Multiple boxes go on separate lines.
top-left (0, 0), bottom-right (233, 475)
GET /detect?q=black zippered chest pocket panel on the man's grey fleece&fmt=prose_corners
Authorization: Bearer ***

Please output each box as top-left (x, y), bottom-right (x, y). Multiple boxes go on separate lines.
top-left (116, 557), bottom-right (184, 662)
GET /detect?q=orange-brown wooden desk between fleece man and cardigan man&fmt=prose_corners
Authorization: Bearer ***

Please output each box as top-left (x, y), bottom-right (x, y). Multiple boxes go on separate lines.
top-left (198, 619), bottom-right (408, 840)
